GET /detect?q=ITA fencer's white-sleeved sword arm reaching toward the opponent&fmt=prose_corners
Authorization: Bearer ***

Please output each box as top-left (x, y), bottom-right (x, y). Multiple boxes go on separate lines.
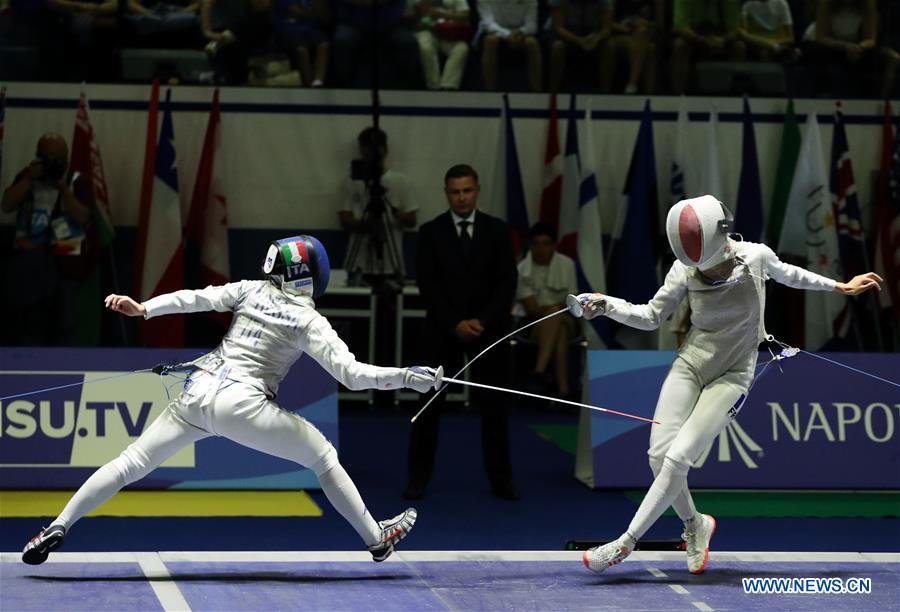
top-left (302, 315), bottom-right (434, 393)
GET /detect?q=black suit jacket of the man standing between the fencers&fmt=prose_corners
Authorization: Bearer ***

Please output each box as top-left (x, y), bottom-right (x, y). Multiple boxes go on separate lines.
top-left (416, 211), bottom-right (518, 338)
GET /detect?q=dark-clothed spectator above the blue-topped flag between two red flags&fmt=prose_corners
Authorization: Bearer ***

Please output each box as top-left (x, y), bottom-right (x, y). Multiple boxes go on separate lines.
top-left (122, 0), bottom-right (200, 48)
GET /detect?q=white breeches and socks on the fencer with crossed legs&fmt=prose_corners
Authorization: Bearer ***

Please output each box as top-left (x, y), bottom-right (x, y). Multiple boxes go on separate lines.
top-left (628, 358), bottom-right (747, 539)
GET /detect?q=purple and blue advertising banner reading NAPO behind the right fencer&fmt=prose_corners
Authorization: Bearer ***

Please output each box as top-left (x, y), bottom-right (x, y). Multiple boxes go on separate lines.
top-left (580, 351), bottom-right (900, 489)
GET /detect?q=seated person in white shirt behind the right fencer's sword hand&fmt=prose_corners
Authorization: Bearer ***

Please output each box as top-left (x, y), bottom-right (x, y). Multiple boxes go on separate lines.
top-left (516, 223), bottom-right (578, 397)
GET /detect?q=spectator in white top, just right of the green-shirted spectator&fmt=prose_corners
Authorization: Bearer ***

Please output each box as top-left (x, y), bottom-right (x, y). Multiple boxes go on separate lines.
top-left (738, 0), bottom-right (794, 62)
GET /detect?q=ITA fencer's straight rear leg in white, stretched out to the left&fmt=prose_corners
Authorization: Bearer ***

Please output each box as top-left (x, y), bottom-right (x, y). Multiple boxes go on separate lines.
top-left (51, 405), bottom-right (209, 530)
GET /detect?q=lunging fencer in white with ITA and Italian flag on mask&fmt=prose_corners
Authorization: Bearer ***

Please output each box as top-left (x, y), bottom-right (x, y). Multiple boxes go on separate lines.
top-left (22, 236), bottom-right (438, 564)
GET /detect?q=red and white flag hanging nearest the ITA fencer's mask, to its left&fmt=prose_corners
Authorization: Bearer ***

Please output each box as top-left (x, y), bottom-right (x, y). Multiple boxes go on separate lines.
top-left (185, 89), bottom-right (231, 344)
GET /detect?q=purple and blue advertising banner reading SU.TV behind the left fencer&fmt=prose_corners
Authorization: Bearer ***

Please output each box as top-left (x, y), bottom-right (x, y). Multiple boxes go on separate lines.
top-left (0, 348), bottom-right (338, 489)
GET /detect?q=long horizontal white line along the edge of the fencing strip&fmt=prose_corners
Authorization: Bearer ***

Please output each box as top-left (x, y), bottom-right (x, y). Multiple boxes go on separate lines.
top-left (0, 550), bottom-right (900, 564)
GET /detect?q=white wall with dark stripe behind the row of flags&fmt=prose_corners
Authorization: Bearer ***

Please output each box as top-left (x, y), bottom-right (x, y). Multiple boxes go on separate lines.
top-left (0, 83), bottom-right (900, 244)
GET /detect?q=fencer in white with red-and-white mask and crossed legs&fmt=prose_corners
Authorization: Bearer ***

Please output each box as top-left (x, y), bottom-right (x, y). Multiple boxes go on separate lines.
top-left (570, 195), bottom-right (881, 574)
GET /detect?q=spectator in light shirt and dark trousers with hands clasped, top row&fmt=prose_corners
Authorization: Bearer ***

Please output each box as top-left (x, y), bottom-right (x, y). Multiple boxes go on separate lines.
top-left (476, 0), bottom-right (543, 91)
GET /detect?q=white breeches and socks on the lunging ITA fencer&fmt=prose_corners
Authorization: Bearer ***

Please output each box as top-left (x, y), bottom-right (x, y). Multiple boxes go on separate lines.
top-left (54, 373), bottom-right (381, 545)
